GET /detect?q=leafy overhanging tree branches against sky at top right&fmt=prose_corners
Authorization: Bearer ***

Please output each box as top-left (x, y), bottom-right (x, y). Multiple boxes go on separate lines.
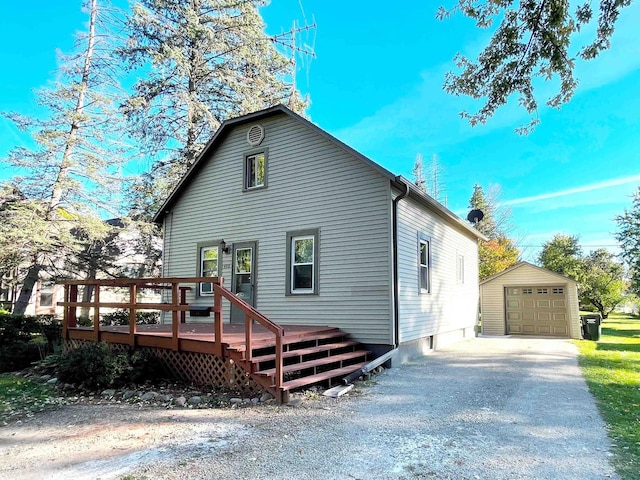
top-left (437, 0), bottom-right (631, 133)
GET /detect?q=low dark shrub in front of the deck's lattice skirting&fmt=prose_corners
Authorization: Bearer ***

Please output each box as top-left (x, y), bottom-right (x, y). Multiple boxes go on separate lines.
top-left (52, 342), bottom-right (163, 389)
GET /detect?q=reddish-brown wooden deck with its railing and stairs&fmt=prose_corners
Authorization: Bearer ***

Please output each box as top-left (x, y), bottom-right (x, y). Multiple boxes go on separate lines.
top-left (58, 277), bottom-right (370, 403)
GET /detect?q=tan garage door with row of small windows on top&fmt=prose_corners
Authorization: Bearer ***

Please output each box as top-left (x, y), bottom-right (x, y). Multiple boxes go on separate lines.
top-left (505, 286), bottom-right (569, 337)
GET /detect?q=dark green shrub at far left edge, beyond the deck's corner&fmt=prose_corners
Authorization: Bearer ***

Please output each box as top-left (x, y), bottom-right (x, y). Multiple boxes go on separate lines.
top-left (0, 314), bottom-right (62, 372)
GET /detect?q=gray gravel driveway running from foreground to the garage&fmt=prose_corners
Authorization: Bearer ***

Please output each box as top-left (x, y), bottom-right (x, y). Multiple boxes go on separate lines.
top-left (0, 337), bottom-right (617, 480)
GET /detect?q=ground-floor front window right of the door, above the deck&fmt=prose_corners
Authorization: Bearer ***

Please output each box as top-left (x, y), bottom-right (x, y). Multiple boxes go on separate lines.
top-left (286, 229), bottom-right (319, 295)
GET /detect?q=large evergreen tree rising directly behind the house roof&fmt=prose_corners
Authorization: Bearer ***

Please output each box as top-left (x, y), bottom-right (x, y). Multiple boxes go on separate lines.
top-left (119, 0), bottom-right (305, 214)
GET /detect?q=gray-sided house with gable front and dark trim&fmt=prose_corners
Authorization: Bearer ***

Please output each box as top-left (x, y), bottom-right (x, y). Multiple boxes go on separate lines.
top-left (154, 106), bottom-right (482, 359)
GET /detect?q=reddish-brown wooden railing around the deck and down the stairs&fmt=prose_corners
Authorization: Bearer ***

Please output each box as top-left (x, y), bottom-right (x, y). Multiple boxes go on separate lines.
top-left (58, 277), bottom-right (284, 388)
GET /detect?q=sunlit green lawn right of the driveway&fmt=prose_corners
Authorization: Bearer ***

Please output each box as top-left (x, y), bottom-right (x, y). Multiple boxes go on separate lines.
top-left (576, 314), bottom-right (640, 480)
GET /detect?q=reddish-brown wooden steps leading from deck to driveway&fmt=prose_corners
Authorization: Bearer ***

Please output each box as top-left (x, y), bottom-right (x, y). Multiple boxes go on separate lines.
top-left (225, 327), bottom-right (371, 403)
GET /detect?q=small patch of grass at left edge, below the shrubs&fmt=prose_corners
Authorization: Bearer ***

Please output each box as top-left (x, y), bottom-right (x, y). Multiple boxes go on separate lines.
top-left (0, 375), bottom-right (61, 426)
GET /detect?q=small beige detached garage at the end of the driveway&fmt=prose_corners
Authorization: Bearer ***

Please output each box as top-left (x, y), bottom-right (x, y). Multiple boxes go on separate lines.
top-left (480, 262), bottom-right (581, 338)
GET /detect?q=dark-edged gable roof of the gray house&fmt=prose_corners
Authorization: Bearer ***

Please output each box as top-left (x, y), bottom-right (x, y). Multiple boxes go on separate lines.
top-left (153, 105), bottom-right (487, 240)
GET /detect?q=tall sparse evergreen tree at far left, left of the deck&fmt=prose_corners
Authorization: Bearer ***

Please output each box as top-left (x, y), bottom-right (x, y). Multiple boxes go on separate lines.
top-left (0, 0), bottom-right (121, 314)
